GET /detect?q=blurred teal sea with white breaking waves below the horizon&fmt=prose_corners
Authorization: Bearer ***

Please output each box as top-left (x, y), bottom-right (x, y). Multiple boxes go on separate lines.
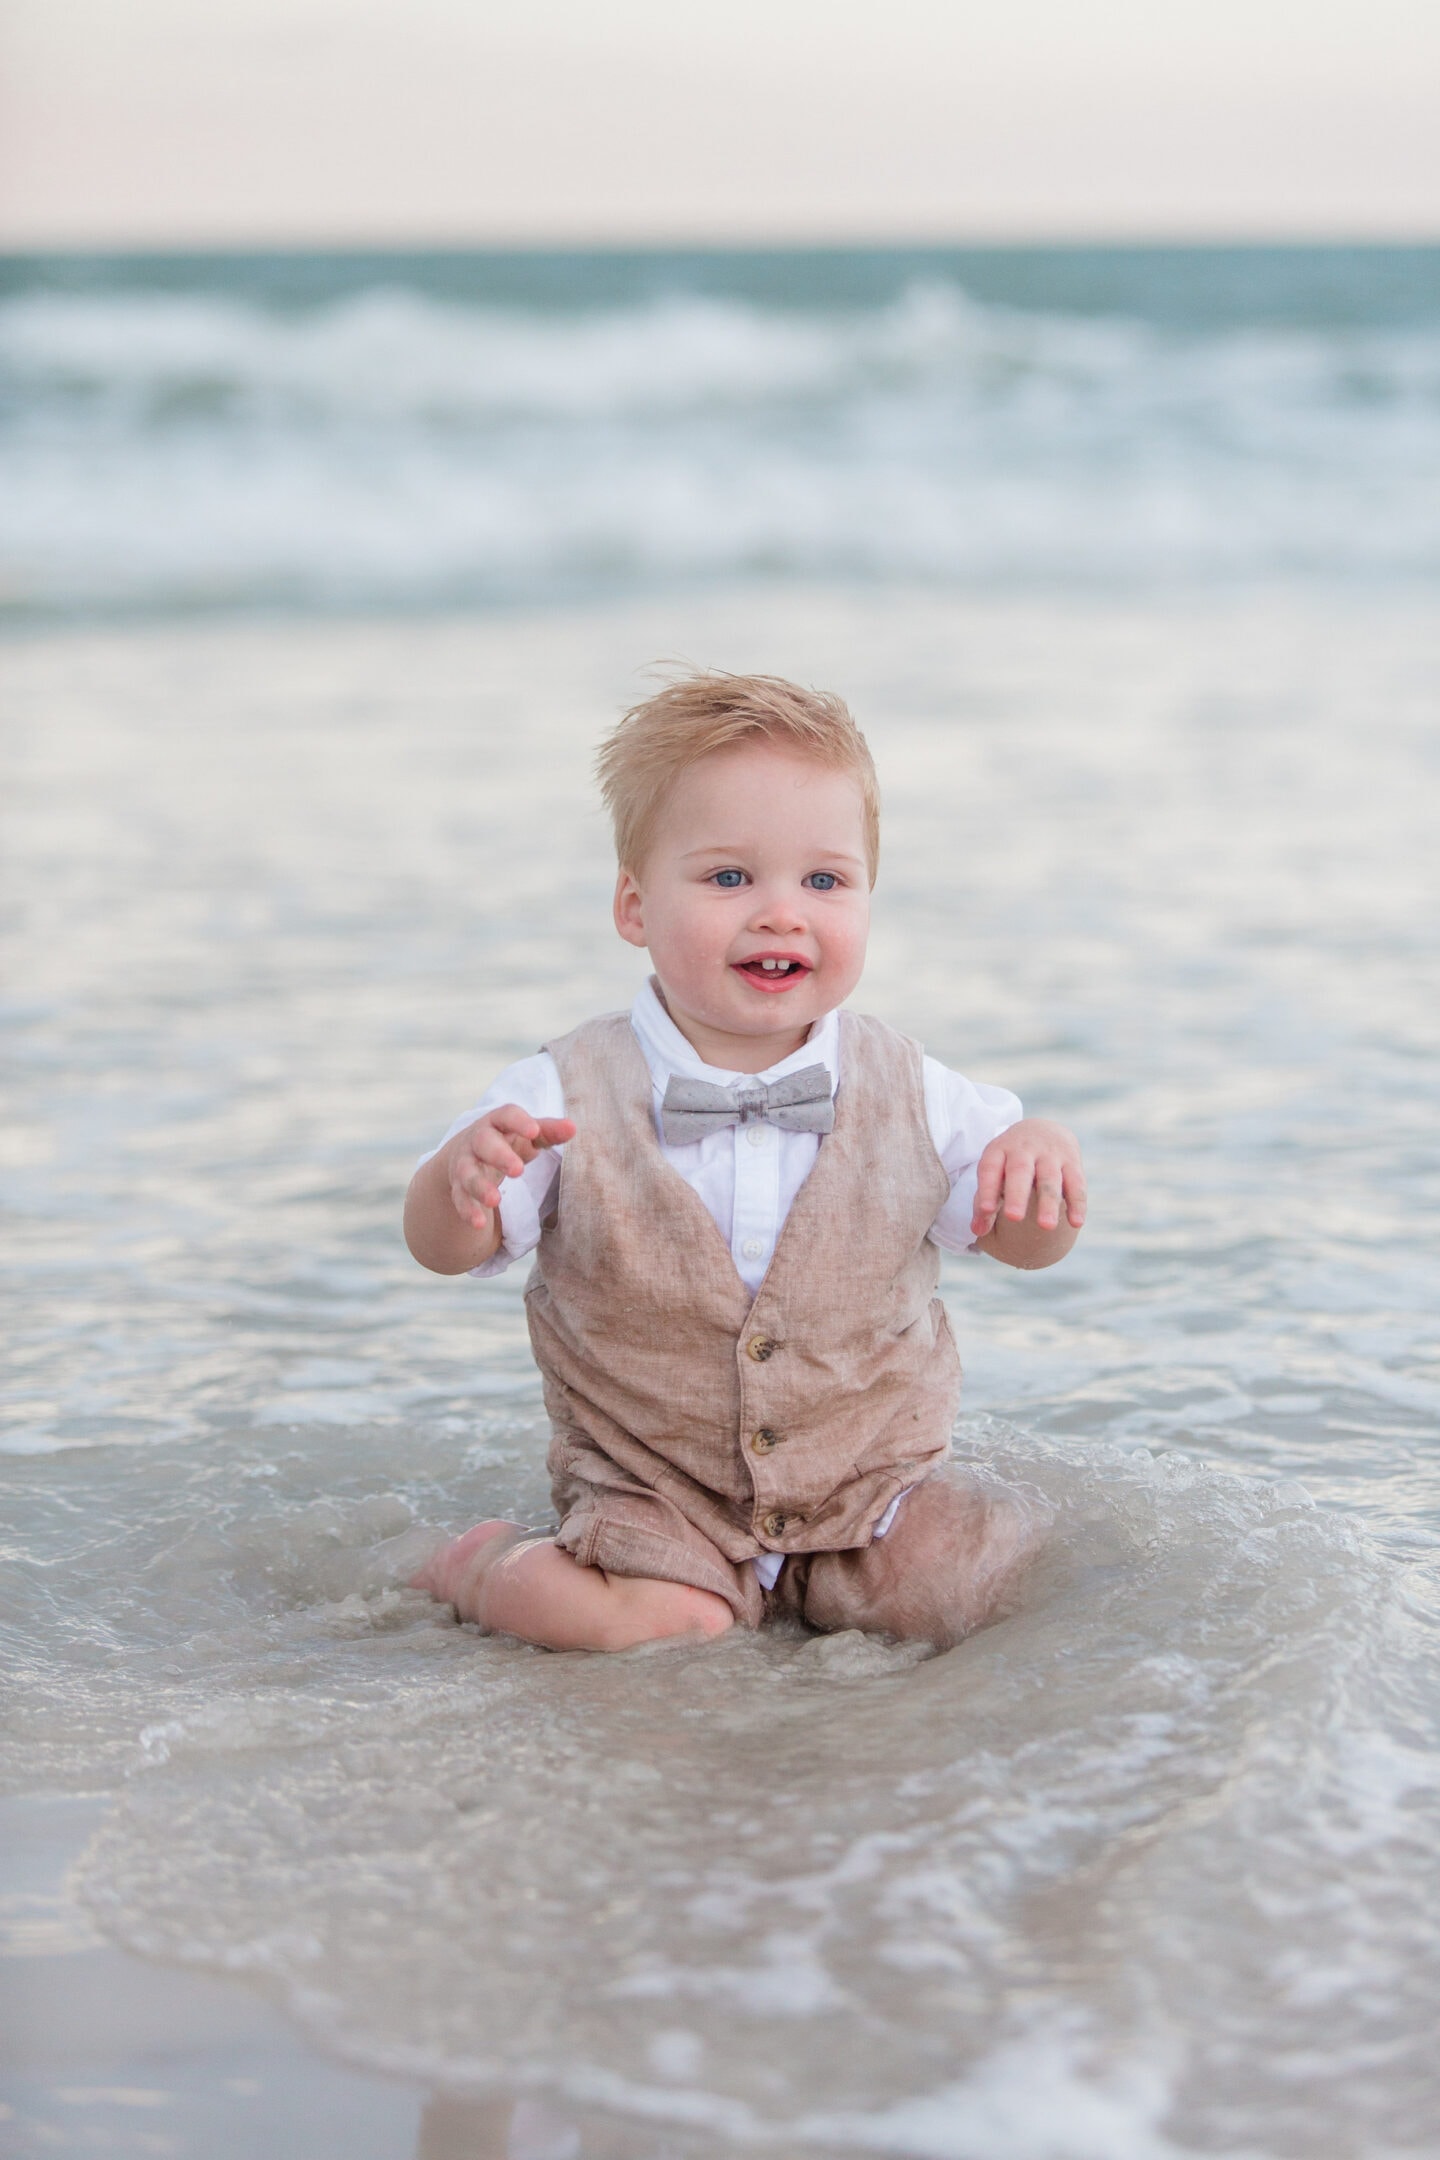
top-left (0, 246), bottom-right (1440, 618)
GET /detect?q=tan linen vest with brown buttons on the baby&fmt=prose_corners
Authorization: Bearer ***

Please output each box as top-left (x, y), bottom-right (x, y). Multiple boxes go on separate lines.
top-left (525, 1013), bottom-right (961, 1562)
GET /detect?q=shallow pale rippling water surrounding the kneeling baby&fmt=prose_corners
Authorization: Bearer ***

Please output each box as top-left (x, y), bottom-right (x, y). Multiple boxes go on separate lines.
top-left (0, 590), bottom-right (1440, 2160)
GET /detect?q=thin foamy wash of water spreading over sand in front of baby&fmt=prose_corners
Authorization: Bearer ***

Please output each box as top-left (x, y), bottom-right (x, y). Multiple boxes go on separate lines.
top-left (50, 1428), bottom-right (1440, 2160)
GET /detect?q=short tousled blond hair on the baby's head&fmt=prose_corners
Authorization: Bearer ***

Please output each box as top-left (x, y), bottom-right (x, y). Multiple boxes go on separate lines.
top-left (596, 670), bottom-right (881, 883)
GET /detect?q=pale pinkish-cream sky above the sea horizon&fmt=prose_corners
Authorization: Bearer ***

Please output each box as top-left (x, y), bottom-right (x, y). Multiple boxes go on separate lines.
top-left (0, 0), bottom-right (1440, 246)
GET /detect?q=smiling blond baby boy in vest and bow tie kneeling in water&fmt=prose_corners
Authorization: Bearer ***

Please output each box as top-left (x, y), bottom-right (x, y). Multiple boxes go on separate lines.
top-left (406, 674), bottom-right (1086, 1650)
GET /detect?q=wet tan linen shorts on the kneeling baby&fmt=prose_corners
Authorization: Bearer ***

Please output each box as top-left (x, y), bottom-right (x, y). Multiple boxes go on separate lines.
top-left (555, 1464), bottom-right (1045, 1648)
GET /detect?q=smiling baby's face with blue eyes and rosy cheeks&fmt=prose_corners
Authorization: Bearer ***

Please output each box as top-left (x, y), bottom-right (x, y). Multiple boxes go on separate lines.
top-left (615, 743), bottom-right (870, 1074)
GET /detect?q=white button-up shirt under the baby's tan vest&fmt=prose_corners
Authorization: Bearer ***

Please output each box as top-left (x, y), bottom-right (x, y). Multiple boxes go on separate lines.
top-left (432, 983), bottom-right (1021, 1294)
